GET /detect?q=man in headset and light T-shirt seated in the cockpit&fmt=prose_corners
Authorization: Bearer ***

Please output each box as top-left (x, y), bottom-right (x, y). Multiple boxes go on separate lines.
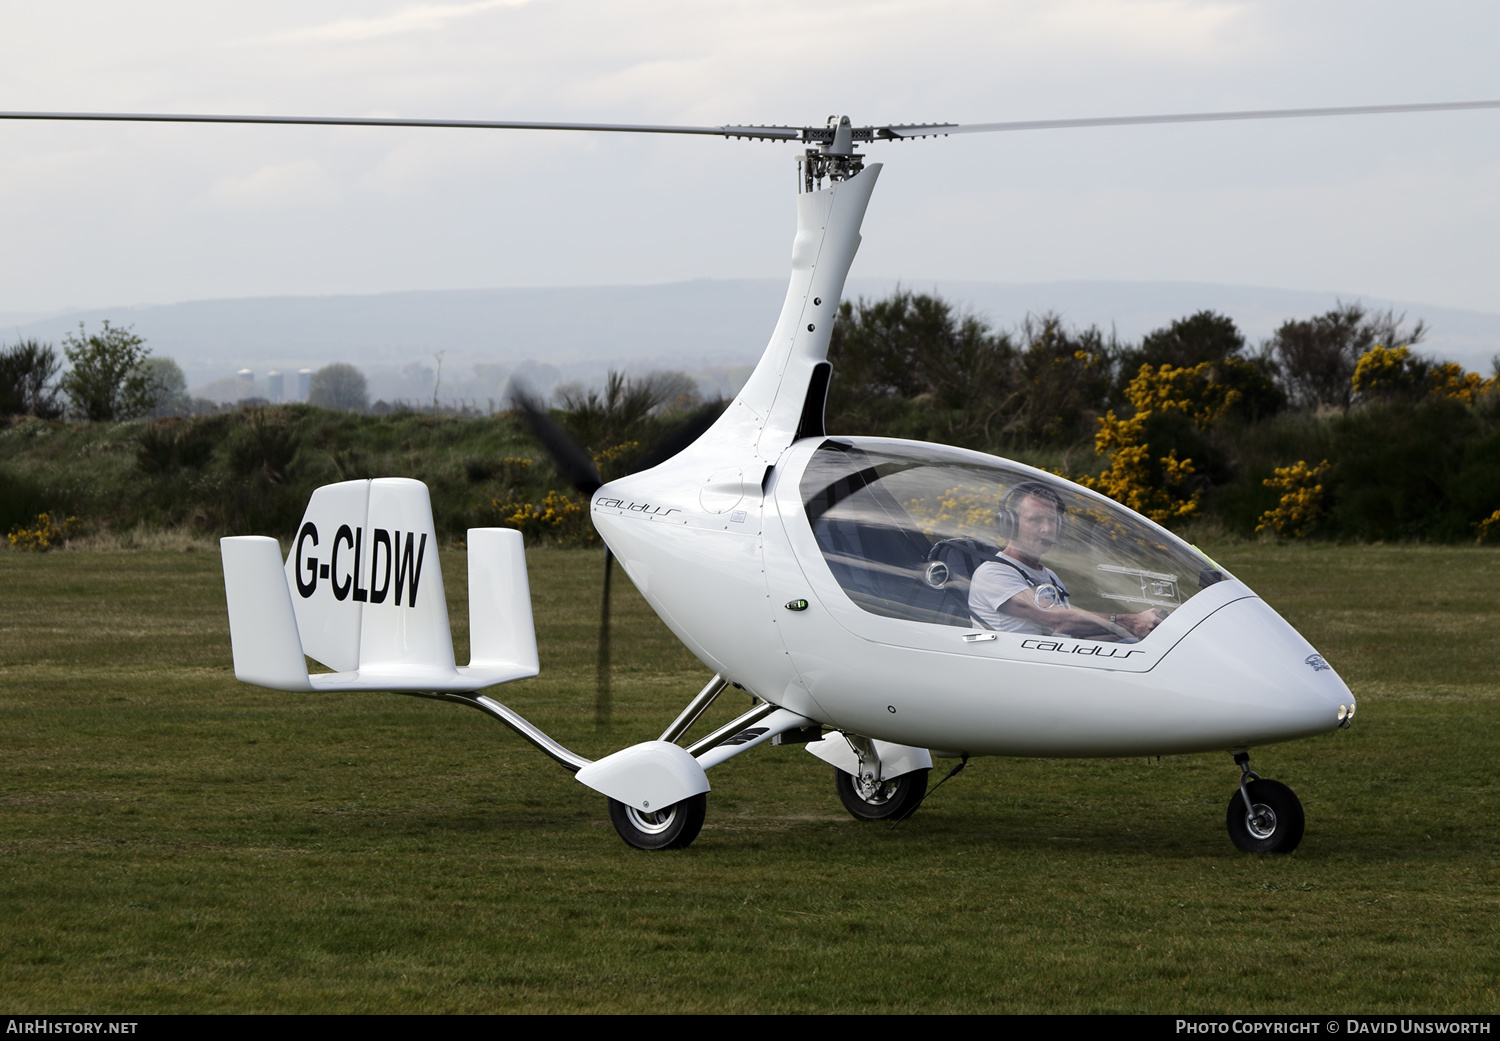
top-left (969, 482), bottom-right (1167, 641)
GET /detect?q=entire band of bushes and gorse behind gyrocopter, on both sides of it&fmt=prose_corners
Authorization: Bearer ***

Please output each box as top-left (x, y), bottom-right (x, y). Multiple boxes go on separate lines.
top-left (0, 291), bottom-right (1500, 542)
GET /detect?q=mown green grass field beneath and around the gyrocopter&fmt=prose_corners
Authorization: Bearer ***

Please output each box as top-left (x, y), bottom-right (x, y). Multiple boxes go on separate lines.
top-left (0, 545), bottom-right (1500, 1014)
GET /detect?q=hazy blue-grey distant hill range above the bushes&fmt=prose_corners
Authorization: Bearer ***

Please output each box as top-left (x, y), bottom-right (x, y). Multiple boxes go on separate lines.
top-left (0, 279), bottom-right (1500, 396)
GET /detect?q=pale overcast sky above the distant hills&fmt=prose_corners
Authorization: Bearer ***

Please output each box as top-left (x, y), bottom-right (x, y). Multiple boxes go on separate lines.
top-left (0, 0), bottom-right (1500, 312)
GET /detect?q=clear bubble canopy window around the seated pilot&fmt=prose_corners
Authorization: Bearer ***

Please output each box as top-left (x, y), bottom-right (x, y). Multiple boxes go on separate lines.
top-left (800, 440), bottom-right (1223, 641)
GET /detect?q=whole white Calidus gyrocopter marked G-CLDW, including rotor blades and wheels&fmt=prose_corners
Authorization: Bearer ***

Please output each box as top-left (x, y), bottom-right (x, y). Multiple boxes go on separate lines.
top-left (0, 101), bottom-right (1500, 852)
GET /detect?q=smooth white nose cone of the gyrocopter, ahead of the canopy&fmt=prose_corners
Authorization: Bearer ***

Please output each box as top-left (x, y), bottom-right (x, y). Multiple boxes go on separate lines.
top-left (1152, 597), bottom-right (1355, 747)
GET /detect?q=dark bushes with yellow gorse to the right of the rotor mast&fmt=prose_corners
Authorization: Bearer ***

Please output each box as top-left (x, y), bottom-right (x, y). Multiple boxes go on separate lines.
top-left (827, 291), bottom-right (1500, 540)
